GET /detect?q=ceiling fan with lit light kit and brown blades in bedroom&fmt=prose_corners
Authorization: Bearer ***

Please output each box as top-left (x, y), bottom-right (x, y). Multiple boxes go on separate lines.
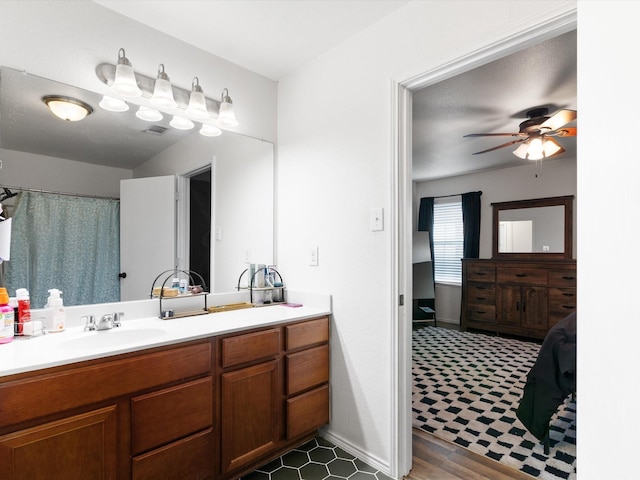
top-left (464, 107), bottom-right (578, 160)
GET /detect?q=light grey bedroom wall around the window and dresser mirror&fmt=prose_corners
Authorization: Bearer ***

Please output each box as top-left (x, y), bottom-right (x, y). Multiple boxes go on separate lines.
top-left (413, 158), bottom-right (579, 323)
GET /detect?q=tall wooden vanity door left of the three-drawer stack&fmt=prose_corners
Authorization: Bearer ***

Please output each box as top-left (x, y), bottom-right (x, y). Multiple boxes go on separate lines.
top-left (221, 360), bottom-right (282, 474)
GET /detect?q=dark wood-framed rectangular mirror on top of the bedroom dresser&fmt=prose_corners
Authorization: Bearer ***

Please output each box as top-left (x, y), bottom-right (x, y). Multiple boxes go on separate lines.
top-left (491, 195), bottom-right (573, 259)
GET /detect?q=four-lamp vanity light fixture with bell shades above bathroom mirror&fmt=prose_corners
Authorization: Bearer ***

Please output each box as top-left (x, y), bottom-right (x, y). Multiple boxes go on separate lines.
top-left (96, 48), bottom-right (239, 137)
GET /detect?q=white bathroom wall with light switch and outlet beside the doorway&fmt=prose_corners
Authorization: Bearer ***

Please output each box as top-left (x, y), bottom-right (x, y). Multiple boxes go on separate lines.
top-left (278, 1), bottom-right (575, 473)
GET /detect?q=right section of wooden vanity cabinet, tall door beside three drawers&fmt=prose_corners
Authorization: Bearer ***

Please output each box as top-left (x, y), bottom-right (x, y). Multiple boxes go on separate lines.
top-left (218, 317), bottom-right (329, 479)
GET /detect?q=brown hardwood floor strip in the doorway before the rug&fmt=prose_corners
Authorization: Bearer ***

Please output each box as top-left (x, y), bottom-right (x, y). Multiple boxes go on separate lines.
top-left (405, 428), bottom-right (532, 480)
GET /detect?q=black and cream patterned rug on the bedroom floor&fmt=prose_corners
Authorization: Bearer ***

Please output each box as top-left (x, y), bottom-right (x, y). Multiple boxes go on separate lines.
top-left (413, 327), bottom-right (577, 480)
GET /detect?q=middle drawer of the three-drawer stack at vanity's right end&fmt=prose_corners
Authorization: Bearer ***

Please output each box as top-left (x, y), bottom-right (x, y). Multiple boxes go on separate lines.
top-left (285, 345), bottom-right (329, 395)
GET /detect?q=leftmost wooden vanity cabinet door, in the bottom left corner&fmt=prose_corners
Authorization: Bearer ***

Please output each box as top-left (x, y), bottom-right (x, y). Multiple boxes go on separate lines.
top-left (0, 405), bottom-right (117, 480)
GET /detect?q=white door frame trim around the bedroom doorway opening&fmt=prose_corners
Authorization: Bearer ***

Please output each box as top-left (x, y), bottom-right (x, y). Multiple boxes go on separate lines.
top-left (390, 6), bottom-right (578, 478)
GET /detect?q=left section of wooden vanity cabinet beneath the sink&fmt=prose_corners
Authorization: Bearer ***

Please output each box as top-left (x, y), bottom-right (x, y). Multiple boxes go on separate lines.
top-left (0, 341), bottom-right (214, 480)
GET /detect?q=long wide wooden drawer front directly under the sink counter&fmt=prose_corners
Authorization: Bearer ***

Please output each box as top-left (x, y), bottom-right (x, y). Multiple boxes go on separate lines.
top-left (0, 342), bottom-right (211, 427)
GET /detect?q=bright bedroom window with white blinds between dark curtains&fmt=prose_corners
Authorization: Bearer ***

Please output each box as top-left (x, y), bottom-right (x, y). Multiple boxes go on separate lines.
top-left (433, 197), bottom-right (464, 285)
